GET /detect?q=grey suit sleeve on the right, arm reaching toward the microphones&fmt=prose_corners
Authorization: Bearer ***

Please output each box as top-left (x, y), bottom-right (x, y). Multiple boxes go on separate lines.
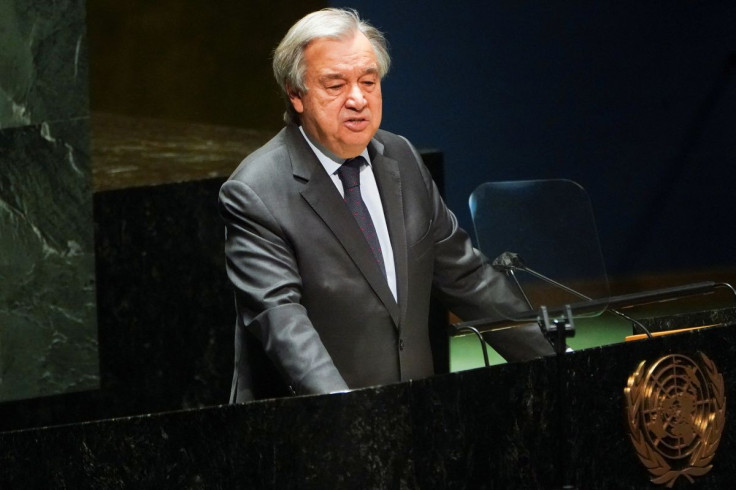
top-left (412, 140), bottom-right (554, 361)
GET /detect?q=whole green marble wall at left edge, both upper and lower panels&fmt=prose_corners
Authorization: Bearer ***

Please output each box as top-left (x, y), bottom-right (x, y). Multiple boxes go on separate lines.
top-left (0, 0), bottom-right (99, 402)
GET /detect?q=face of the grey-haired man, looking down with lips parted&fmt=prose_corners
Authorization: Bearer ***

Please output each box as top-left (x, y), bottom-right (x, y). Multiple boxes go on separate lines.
top-left (289, 32), bottom-right (382, 158)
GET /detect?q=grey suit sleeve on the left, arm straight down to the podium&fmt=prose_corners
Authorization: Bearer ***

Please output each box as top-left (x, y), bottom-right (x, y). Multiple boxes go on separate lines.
top-left (219, 180), bottom-right (347, 394)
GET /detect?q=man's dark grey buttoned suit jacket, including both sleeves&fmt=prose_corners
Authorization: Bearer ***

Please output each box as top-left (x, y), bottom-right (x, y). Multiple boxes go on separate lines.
top-left (219, 125), bottom-right (552, 402)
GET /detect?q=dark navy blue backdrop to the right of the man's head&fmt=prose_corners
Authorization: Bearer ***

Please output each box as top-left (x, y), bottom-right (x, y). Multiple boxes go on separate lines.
top-left (334, 0), bottom-right (736, 284)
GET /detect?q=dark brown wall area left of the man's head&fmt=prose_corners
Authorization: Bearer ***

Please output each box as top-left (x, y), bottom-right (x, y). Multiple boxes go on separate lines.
top-left (87, 0), bottom-right (326, 130)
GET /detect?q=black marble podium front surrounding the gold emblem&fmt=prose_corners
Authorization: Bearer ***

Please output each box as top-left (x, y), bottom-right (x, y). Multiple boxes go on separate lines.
top-left (0, 310), bottom-right (736, 489)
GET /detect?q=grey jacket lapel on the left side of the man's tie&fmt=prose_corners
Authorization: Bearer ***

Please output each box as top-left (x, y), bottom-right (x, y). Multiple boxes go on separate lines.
top-left (286, 126), bottom-right (399, 325)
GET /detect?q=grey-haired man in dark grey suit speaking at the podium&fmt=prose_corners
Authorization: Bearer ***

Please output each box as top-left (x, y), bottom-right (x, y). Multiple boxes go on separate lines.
top-left (219, 9), bottom-right (553, 402)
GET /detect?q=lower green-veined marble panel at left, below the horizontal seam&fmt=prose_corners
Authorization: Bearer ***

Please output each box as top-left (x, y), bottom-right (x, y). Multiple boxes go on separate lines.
top-left (0, 119), bottom-right (99, 401)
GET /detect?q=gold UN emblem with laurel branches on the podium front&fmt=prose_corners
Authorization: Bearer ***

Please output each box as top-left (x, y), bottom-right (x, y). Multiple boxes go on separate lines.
top-left (624, 352), bottom-right (726, 488)
